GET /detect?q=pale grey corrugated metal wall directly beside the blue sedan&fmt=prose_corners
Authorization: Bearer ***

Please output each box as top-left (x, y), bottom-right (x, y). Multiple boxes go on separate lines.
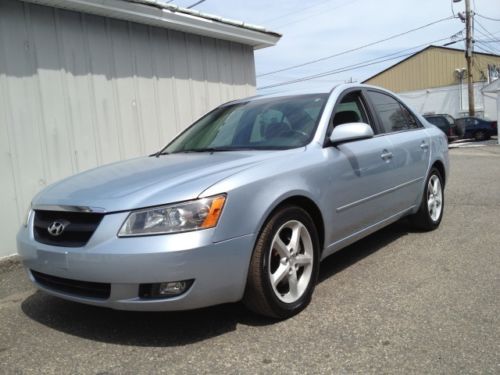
top-left (0, 0), bottom-right (255, 257)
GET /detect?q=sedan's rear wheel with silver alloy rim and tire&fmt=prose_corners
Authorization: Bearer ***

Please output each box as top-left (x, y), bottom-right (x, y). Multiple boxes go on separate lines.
top-left (410, 168), bottom-right (444, 231)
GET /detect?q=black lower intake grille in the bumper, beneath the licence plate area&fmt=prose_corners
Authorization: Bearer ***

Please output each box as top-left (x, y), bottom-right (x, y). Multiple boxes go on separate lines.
top-left (30, 270), bottom-right (111, 299)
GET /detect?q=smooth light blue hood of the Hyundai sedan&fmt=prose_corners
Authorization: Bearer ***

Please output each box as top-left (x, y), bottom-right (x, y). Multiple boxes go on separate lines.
top-left (33, 149), bottom-right (300, 212)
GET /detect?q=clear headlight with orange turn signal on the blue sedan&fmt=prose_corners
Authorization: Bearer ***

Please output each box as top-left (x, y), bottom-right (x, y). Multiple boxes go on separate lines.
top-left (118, 195), bottom-right (226, 237)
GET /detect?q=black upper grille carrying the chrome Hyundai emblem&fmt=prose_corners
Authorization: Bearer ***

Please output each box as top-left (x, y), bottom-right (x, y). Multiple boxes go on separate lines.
top-left (33, 210), bottom-right (104, 247)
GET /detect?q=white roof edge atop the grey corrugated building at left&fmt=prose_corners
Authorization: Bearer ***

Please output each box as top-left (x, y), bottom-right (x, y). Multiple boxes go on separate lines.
top-left (24, 0), bottom-right (281, 49)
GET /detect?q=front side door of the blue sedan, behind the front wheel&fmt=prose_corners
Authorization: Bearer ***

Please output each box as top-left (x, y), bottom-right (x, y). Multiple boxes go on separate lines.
top-left (324, 90), bottom-right (394, 248)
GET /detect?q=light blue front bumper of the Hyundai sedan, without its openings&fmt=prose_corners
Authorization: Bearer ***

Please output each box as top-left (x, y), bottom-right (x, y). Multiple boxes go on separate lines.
top-left (17, 213), bottom-right (255, 311)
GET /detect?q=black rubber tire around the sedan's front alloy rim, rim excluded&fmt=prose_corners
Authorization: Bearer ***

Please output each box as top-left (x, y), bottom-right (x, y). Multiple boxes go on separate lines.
top-left (243, 206), bottom-right (320, 319)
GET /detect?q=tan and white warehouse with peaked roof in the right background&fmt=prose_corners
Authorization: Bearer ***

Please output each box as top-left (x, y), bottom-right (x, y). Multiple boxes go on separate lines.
top-left (363, 46), bottom-right (500, 120)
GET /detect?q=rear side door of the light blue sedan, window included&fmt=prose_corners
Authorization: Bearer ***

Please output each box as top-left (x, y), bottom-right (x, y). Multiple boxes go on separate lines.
top-left (367, 89), bottom-right (431, 212)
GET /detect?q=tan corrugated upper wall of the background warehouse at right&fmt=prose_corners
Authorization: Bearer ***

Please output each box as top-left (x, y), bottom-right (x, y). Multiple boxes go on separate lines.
top-left (365, 47), bottom-right (500, 92)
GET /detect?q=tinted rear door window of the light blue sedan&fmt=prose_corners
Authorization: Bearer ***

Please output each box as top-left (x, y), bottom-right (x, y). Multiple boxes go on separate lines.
top-left (368, 91), bottom-right (418, 133)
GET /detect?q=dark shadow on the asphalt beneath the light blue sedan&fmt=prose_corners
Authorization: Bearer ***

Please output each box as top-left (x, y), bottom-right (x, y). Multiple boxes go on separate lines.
top-left (21, 222), bottom-right (408, 347)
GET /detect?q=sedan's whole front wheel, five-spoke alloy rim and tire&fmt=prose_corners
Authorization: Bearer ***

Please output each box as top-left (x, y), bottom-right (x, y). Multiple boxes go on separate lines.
top-left (243, 206), bottom-right (319, 319)
